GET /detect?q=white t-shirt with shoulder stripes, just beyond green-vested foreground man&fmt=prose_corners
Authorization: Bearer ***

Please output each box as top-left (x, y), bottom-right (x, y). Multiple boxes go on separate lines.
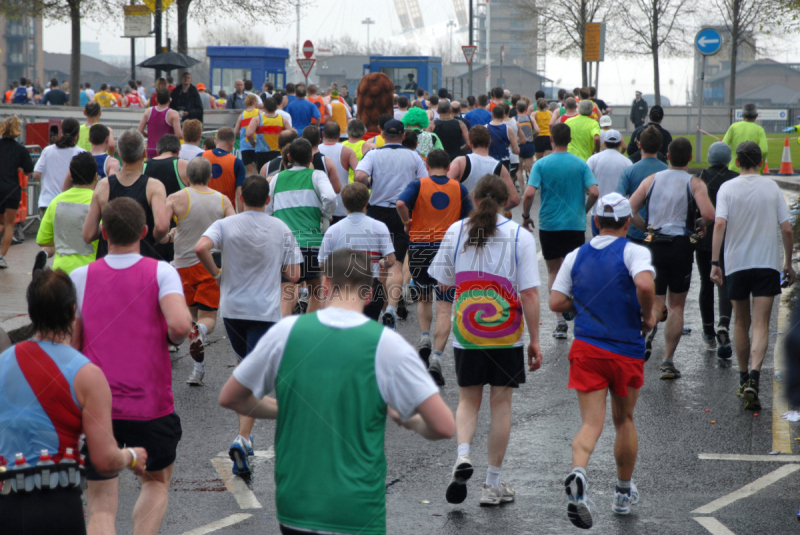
top-left (318, 213), bottom-right (394, 277)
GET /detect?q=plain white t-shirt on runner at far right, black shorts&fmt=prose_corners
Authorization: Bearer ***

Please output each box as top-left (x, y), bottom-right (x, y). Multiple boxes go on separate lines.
top-left (716, 175), bottom-right (789, 275)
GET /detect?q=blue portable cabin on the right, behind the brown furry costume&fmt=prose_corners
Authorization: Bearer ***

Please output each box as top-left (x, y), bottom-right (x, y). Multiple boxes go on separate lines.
top-left (365, 56), bottom-right (442, 100)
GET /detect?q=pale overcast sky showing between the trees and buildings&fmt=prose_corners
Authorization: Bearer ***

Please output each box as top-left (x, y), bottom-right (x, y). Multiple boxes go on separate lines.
top-left (44, 0), bottom-right (800, 105)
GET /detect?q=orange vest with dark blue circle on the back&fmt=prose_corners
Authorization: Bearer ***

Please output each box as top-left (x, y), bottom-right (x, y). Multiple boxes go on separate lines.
top-left (409, 177), bottom-right (461, 243)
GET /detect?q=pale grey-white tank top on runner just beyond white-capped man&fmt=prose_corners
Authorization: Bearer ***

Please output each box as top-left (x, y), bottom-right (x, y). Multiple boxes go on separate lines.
top-left (647, 169), bottom-right (692, 236)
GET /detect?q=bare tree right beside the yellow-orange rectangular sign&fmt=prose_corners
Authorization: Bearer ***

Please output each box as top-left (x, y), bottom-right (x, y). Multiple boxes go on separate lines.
top-left (511, 0), bottom-right (612, 86)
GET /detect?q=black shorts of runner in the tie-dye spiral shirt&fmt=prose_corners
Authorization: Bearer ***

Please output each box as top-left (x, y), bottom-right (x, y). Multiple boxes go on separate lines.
top-left (453, 347), bottom-right (525, 388)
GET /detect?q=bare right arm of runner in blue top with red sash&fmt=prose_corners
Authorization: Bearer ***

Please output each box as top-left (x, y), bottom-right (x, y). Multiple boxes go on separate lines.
top-left (74, 364), bottom-right (147, 477)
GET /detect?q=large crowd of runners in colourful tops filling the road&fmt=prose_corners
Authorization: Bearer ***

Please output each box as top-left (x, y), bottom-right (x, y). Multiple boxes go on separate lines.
top-left (0, 77), bottom-right (795, 534)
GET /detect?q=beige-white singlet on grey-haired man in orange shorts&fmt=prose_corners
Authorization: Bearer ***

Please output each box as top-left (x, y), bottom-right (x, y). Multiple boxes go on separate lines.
top-left (172, 188), bottom-right (225, 269)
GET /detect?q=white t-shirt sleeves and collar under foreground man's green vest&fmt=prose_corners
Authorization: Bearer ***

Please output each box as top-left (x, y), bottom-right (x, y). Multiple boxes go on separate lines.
top-left (233, 307), bottom-right (439, 421)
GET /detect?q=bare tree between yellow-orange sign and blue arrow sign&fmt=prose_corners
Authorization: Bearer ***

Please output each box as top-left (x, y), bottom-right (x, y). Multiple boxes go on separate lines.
top-left (615, 0), bottom-right (696, 106)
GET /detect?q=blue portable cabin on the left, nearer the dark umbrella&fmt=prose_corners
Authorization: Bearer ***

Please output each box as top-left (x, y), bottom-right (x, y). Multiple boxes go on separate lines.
top-left (206, 46), bottom-right (289, 95)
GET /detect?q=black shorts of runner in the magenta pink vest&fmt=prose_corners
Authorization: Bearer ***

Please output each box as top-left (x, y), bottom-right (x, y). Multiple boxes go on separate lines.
top-left (81, 412), bottom-right (183, 481)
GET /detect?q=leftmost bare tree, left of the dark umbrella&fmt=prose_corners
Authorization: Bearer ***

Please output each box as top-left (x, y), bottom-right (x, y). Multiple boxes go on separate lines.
top-left (0, 0), bottom-right (114, 106)
